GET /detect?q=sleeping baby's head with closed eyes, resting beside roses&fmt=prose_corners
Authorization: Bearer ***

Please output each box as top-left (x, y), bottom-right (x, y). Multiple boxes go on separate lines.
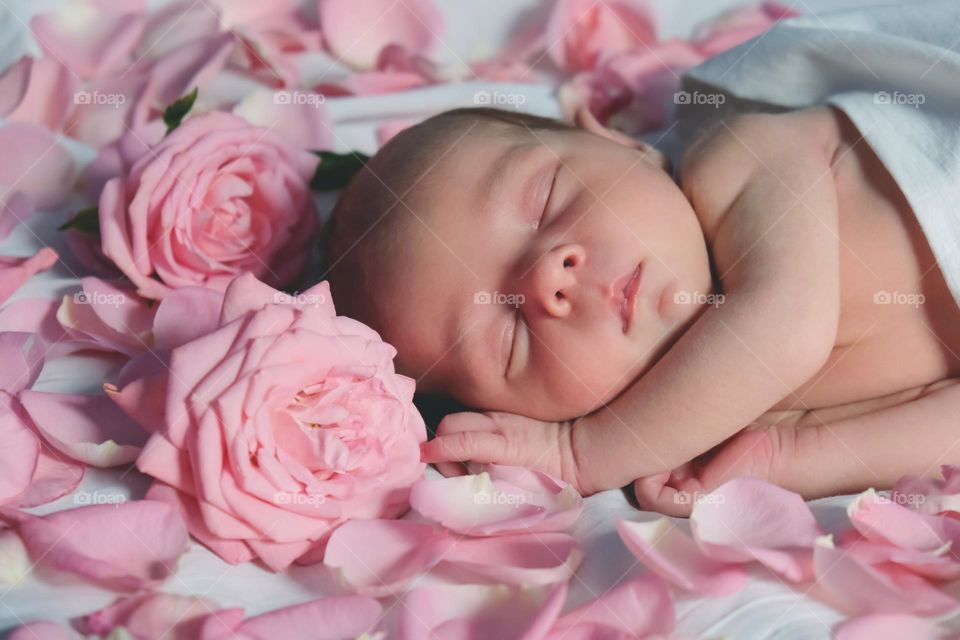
top-left (328, 109), bottom-right (712, 420)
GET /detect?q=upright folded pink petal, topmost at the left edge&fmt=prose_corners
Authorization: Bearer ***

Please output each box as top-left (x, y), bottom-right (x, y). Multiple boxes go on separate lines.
top-left (0, 55), bottom-right (80, 131)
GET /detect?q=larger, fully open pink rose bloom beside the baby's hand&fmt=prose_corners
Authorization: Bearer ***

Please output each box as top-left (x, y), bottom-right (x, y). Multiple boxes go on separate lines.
top-left (107, 274), bottom-right (427, 570)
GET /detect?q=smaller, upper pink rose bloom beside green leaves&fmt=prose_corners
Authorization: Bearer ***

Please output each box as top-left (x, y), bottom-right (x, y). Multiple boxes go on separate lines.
top-left (100, 112), bottom-right (319, 299)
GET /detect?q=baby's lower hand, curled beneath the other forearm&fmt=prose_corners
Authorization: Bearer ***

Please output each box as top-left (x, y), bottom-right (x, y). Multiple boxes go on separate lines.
top-left (633, 424), bottom-right (796, 517)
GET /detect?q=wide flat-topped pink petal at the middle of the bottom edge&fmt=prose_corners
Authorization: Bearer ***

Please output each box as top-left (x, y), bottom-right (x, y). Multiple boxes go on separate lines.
top-left (388, 582), bottom-right (567, 640)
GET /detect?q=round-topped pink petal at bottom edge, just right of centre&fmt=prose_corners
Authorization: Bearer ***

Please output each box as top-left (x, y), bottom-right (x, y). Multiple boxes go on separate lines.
top-left (547, 575), bottom-right (676, 640)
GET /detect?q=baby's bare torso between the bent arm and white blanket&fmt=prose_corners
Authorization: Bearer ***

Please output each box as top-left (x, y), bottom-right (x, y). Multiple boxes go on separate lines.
top-left (688, 106), bottom-right (960, 425)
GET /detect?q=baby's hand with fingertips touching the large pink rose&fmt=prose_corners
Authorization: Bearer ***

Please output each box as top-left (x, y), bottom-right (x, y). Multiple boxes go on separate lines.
top-left (420, 411), bottom-right (582, 493)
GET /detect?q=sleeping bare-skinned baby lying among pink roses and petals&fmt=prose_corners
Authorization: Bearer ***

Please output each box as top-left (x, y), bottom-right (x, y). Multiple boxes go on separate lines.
top-left (320, 2), bottom-right (960, 515)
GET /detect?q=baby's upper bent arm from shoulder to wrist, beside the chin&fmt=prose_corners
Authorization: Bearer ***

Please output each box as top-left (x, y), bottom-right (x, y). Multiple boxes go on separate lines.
top-left (571, 115), bottom-right (840, 493)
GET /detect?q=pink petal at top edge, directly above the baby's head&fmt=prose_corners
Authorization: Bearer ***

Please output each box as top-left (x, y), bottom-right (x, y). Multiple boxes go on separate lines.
top-left (319, 0), bottom-right (443, 69)
